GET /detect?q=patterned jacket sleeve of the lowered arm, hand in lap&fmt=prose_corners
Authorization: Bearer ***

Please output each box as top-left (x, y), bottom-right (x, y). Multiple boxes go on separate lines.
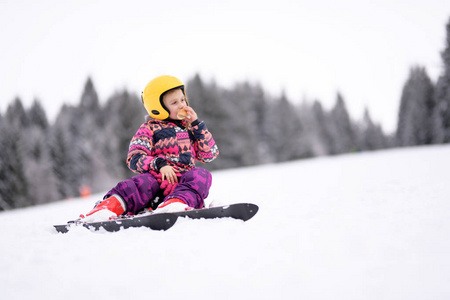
top-left (127, 123), bottom-right (165, 174)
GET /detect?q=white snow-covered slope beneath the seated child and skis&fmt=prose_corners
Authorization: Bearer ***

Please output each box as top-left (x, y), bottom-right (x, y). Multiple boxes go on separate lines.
top-left (0, 145), bottom-right (450, 300)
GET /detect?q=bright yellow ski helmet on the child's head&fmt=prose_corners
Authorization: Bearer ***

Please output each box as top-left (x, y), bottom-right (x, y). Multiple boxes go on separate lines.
top-left (141, 75), bottom-right (189, 120)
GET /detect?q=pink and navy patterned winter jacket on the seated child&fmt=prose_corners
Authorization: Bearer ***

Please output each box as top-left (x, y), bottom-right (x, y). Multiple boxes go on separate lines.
top-left (127, 119), bottom-right (219, 174)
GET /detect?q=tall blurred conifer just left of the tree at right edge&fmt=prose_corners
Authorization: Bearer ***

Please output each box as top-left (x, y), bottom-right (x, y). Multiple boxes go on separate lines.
top-left (397, 67), bottom-right (435, 146)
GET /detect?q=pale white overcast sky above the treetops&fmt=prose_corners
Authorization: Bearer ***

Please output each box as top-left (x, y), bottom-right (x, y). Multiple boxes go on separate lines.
top-left (0, 0), bottom-right (450, 131)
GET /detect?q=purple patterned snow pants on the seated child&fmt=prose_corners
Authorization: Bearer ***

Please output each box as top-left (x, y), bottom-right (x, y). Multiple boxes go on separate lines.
top-left (104, 168), bottom-right (212, 214)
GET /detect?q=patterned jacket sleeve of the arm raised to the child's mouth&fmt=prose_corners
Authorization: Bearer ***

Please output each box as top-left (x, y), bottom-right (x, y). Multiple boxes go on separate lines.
top-left (192, 121), bottom-right (219, 163)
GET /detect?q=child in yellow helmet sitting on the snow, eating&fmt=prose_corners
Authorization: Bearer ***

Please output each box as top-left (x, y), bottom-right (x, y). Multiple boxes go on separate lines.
top-left (80, 76), bottom-right (219, 222)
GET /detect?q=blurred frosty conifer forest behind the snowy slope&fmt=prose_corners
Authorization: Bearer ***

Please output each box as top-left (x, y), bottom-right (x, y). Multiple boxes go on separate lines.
top-left (0, 17), bottom-right (450, 211)
